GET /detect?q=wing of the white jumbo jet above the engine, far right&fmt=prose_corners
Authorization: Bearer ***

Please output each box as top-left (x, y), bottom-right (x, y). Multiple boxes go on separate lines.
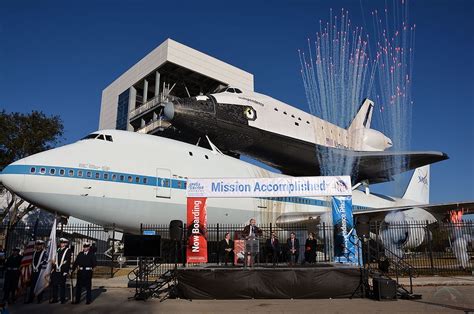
top-left (353, 202), bottom-right (474, 220)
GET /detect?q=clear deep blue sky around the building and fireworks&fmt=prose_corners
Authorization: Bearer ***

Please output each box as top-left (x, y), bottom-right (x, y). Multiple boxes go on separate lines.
top-left (0, 0), bottom-right (474, 203)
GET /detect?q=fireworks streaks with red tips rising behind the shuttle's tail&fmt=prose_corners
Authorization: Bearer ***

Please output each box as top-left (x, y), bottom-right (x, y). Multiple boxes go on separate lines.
top-left (299, 0), bottom-right (415, 190)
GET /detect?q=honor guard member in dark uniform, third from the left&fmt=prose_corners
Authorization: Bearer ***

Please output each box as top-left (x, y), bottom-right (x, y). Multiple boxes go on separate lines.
top-left (51, 238), bottom-right (72, 304)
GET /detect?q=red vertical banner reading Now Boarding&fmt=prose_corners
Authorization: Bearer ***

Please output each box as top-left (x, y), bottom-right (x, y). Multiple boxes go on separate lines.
top-left (186, 197), bottom-right (207, 263)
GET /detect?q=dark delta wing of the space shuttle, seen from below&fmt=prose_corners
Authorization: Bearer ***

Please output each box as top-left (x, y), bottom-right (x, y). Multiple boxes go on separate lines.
top-left (237, 132), bottom-right (449, 184)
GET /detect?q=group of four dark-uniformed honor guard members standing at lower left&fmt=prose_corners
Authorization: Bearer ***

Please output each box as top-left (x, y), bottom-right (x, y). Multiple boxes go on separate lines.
top-left (3, 238), bottom-right (97, 304)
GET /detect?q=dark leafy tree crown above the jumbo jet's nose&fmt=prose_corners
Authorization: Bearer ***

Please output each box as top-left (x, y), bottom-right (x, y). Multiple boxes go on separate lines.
top-left (0, 110), bottom-right (64, 170)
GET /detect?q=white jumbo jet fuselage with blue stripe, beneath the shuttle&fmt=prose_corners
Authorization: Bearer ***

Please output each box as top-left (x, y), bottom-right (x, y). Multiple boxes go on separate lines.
top-left (1, 130), bottom-right (432, 231)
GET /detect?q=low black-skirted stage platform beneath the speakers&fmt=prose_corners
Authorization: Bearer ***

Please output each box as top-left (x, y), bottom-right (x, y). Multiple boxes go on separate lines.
top-left (177, 264), bottom-right (360, 299)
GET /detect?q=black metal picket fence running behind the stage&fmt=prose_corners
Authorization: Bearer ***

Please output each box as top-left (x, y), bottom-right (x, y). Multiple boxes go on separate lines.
top-left (0, 221), bottom-right (474, 277)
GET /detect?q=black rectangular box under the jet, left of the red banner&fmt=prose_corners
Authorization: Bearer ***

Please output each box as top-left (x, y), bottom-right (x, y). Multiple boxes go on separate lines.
top-left (123, 234), bottom-right (161, 257)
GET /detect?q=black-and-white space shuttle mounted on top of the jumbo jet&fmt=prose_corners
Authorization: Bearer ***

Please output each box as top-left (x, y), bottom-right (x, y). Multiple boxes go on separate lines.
top-left (162, 87), bottom-right (448, 183)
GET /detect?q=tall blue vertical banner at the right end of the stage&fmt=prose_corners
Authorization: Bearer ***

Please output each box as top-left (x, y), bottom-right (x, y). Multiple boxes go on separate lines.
top-left (332, 196), bottom-right (362, 265)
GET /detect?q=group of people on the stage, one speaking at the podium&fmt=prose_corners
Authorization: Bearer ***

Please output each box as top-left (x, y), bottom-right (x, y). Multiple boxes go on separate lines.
top-left (218, 218), bottom-right (318, 266)
